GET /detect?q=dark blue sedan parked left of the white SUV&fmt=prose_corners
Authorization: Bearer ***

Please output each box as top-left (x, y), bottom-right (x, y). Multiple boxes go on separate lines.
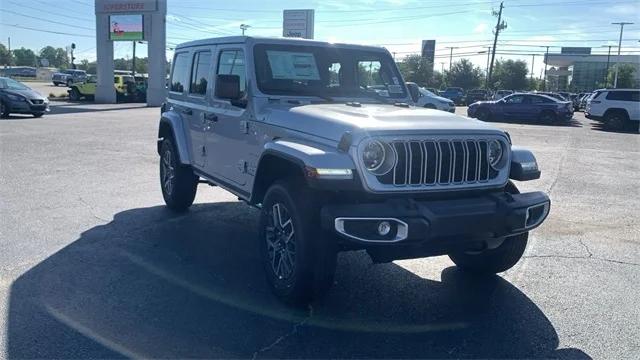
top-left (467, 93), bottom-right (573, 123)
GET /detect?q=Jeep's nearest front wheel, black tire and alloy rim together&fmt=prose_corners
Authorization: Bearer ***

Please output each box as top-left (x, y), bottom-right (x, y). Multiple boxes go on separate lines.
top-left (258, 179), bottom-right (337, 305)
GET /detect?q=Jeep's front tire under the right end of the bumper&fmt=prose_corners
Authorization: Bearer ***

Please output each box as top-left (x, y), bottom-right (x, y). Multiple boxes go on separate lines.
top-left (449, 182), bottom-right (529, 274)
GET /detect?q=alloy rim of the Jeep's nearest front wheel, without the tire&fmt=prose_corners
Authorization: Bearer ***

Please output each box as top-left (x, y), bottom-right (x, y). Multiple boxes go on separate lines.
top-left (265, 203), bottom-right (296, 280)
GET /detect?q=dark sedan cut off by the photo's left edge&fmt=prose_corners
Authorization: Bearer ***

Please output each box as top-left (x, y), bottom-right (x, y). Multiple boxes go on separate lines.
top-left (0, 77), bottom-right (49, 117)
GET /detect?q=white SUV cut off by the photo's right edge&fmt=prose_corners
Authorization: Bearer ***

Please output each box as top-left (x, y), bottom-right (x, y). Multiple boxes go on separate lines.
top-left (584, 89), bottom-right (640, 131)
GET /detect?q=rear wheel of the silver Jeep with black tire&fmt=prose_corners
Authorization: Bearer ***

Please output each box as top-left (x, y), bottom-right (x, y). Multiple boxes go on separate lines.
top-left (160, 138), bottom-right (198, 212)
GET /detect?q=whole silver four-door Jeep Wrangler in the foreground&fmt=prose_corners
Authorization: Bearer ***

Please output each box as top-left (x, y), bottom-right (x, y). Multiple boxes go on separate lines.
top-left (158, 37), bottom-right (550, 303)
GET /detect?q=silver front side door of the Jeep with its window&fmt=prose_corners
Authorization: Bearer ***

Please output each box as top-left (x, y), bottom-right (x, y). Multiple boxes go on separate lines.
top-left (206, 44), bottom-right (249, 190)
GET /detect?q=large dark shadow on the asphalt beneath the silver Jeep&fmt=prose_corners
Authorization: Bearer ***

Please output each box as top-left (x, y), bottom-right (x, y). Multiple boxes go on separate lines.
top-left (6, 203), bottom-right (589, 359)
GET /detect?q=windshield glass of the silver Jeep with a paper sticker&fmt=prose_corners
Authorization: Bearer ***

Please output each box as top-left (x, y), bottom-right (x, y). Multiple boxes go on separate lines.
top-left (254, 44), bottom-right (407, 102)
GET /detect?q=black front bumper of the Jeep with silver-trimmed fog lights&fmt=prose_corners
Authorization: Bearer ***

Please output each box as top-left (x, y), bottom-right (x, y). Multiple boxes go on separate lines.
top-left (321, 192), bottom-right (551, 258)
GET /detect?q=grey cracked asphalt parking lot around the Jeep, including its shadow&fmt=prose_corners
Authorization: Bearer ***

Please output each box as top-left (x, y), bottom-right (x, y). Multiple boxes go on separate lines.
top-left (0, 100), bottom-right (640, 359)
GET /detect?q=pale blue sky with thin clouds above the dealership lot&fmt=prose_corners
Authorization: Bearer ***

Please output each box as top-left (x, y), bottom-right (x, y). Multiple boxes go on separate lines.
top-left (0, 0), bottom-right (640, 77)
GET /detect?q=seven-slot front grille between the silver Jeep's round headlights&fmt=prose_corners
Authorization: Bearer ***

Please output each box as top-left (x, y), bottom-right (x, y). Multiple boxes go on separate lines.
top-left (377, 139), bottom-right (498, 186)
